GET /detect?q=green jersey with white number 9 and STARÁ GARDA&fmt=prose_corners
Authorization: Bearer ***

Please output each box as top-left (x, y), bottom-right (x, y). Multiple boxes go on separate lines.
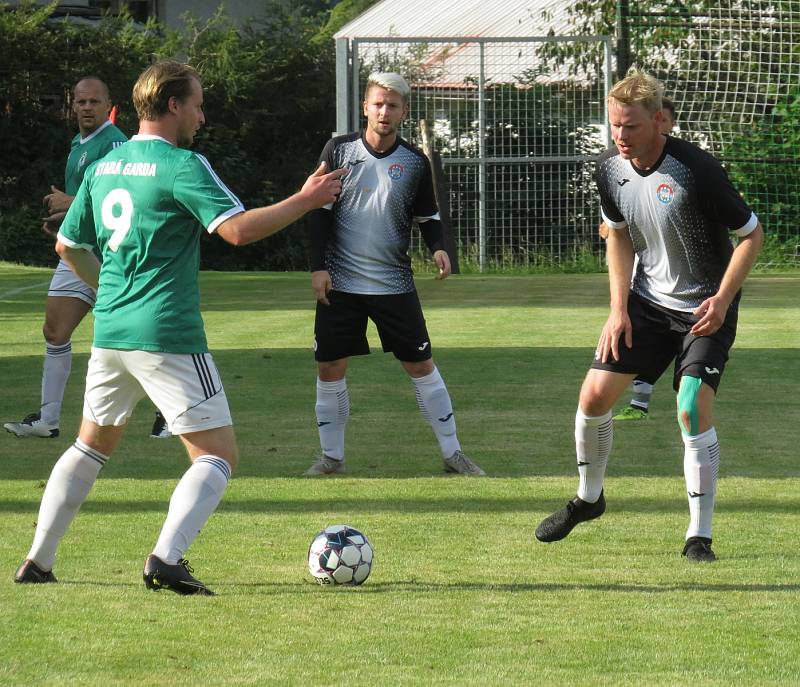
top-left (58, 135), bottom-right (244, 353)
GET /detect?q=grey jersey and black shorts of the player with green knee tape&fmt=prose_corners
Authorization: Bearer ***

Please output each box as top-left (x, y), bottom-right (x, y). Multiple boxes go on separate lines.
top-left (592, 137), bottom-right (758, 389)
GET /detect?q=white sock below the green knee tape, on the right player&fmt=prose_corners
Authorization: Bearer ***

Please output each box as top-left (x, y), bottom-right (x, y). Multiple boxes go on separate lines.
top-left (683, 427), bottom-right (719, 539)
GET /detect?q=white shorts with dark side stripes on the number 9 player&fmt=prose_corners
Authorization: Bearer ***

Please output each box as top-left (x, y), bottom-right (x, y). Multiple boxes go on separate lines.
top-left (83, 347), bottom-right (233, 434)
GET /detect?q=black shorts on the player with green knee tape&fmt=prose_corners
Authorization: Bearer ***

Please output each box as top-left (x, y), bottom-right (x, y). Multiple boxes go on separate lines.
top-left (592, 293), bottom-right (739, 391)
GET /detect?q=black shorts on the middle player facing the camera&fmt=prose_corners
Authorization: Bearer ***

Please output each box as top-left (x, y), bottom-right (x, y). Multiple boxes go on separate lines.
top-left (314, 291), bottom-right (432, 363)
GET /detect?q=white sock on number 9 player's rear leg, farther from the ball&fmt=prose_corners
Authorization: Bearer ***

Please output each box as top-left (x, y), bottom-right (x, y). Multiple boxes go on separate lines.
top-left (27, 439), bottom-right (108, 570)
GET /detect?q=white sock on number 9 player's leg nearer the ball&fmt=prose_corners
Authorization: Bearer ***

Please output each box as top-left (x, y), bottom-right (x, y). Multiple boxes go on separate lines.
top-left (153, 455), bottom-right (231, 565)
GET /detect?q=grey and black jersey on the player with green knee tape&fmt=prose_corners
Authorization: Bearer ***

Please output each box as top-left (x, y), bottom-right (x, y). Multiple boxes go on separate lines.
top-left (597, 137), bottom-right (758, 312)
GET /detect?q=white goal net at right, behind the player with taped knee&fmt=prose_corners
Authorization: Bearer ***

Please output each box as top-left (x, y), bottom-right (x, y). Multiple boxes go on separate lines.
top-left (618, 0), bottom-right (800, 264)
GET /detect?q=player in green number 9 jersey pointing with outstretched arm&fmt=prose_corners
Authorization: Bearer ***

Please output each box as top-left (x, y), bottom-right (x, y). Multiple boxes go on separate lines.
top-left (15, 61), bottom-right (344, 594)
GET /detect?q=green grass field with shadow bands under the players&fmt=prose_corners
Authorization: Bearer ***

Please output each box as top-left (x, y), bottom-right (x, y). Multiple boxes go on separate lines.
top-left (0, 265), bottom-right (800, 687)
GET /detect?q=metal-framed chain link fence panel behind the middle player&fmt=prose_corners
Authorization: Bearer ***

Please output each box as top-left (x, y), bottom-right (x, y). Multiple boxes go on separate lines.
top-left (337, 37), bottom-right (611, 270)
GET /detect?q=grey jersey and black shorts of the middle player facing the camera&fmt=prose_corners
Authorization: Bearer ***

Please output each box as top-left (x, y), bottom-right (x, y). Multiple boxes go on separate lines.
top-left (309, 132), bottom-right (442, 361)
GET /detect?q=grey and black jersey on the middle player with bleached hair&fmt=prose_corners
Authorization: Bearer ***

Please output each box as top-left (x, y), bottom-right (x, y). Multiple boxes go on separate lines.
top-left (320, 132), bottom-right (439, 295)
